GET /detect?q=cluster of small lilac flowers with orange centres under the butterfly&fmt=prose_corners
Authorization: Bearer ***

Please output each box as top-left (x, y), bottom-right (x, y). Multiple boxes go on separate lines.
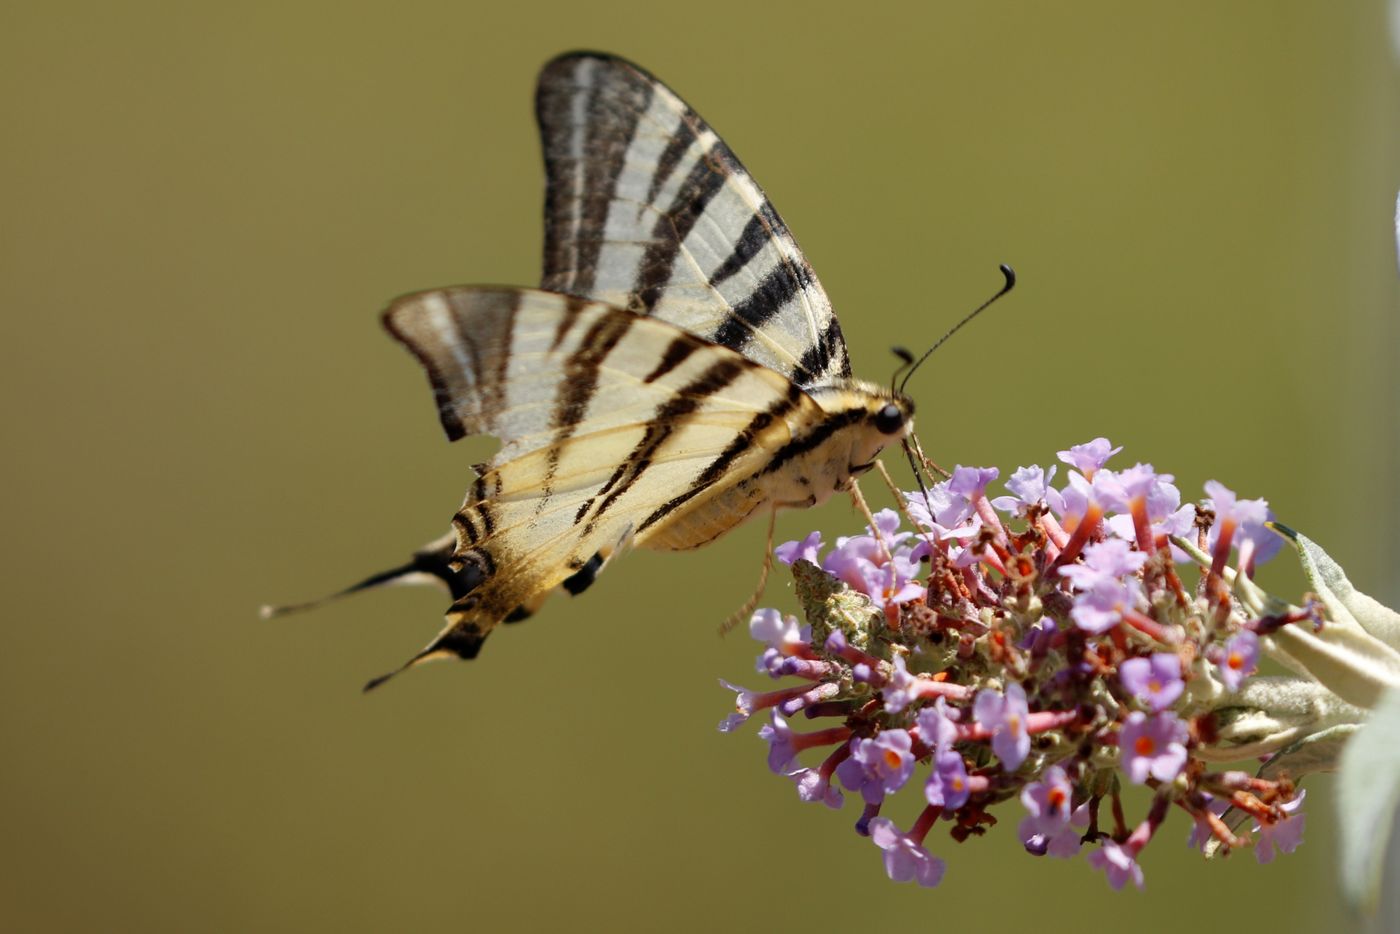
top-left (720, 438), bottom-right (1323, 888)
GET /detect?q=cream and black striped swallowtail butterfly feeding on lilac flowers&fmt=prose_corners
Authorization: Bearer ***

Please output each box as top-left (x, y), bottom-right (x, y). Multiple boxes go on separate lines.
top-left (269, 52), bottom-right (914, 690)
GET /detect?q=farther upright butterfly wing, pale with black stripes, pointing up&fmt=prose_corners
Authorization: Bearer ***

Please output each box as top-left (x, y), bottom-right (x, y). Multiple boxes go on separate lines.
top-left (536, 53), bottom-right (850, 386)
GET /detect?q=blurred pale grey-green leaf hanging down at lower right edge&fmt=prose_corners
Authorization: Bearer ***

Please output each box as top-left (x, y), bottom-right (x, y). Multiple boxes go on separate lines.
top-left (1337, 690), bottom-right (1400, 910)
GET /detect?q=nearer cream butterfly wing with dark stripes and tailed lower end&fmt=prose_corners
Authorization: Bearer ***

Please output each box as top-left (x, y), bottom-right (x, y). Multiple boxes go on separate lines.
top-left (371, 287), bottom-right (820, 686)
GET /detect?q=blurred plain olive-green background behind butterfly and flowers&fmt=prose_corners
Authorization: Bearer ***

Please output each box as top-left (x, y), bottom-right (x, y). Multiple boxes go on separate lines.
top-left (0, 0), bottom-right (1400, 934)
